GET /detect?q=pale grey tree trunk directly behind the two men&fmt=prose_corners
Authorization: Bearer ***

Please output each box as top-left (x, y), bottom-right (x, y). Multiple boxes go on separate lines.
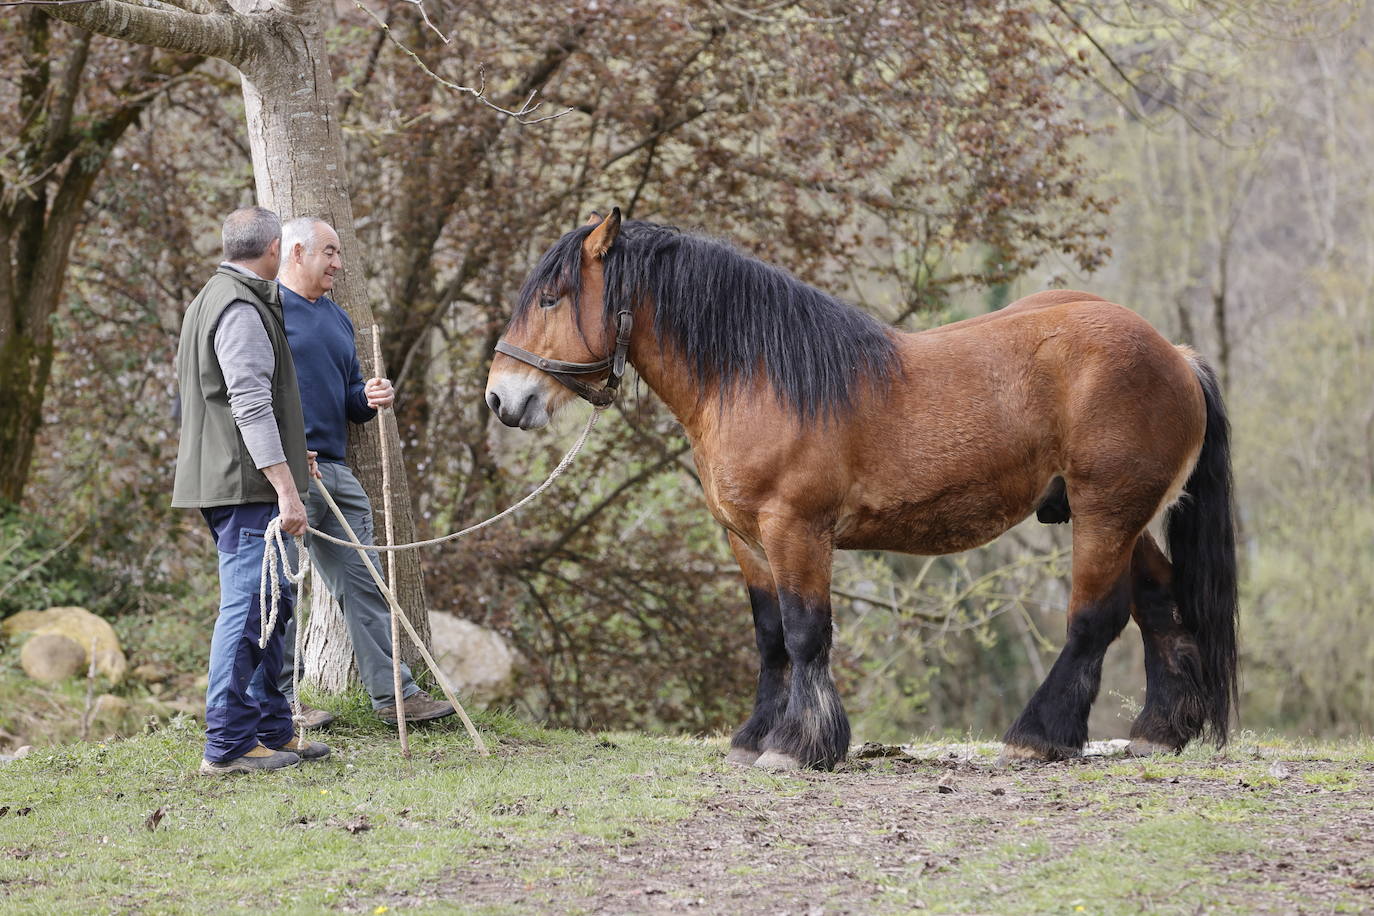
top-left (230, 4), bottom-right (430, 691)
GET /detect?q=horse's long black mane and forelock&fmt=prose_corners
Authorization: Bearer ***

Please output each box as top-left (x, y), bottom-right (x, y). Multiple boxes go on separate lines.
top-left (513, 220), bottom-right (897, 419)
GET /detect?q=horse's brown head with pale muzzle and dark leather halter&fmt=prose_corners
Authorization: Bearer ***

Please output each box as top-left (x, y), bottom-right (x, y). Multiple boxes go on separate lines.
top-left (486, 207), bottom-right (629, 430)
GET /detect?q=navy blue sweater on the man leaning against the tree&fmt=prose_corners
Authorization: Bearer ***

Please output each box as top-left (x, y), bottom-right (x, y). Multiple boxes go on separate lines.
top-left (279, 284), bottom-right (376, 463)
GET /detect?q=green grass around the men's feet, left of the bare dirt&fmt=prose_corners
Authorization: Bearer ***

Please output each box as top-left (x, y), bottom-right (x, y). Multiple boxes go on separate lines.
top-left (0, 710), bottom-right (719, 913)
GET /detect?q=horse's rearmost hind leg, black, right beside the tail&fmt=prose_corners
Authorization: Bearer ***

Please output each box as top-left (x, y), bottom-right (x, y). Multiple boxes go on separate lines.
top-left (1129, 533), bottom-right (1206, 754)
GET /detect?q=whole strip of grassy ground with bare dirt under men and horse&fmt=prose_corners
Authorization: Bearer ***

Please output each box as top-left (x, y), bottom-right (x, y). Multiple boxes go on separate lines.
top-left (0, 696), bottom-right (1374, 916)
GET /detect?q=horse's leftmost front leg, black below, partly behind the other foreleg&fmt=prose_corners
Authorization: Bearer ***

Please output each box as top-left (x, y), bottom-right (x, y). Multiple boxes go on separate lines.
top-left (727, 534), bottom-right (787, 766)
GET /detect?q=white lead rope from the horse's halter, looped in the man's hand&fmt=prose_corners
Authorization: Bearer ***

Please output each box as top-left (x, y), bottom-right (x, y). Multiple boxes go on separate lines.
top-left (258, 408), bottom-right (605, 742)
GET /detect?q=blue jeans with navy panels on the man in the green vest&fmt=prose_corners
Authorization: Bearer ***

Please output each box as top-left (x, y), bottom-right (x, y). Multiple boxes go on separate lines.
top-left (201, 503), bottom-right (295, 764)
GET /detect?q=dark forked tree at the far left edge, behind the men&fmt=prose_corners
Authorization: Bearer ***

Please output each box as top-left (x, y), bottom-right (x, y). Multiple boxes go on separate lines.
top-left (0, 8), bottom-right (201, 503)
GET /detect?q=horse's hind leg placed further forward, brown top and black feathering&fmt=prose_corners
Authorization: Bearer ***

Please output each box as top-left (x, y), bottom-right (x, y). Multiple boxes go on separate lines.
top-left (1003, 515), bottom-right (1143, 761)
